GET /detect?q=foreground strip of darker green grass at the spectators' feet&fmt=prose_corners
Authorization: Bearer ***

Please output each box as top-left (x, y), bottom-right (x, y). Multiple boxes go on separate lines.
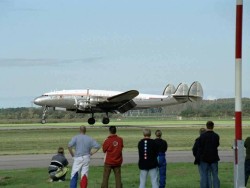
top-left (0, 163), bottom-right (236, 188)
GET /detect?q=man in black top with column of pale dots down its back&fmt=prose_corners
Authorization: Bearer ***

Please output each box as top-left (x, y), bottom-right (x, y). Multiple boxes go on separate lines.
top-left (138, 129), bottom-right (159, 188)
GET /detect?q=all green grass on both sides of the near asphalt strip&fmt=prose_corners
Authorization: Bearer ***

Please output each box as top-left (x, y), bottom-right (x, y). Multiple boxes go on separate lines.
top-left (0, 120), bottom-right (250, 188)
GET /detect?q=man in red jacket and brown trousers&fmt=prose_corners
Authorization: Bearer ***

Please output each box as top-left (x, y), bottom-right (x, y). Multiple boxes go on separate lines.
top-left (102, 126), bottom-right (123, 188)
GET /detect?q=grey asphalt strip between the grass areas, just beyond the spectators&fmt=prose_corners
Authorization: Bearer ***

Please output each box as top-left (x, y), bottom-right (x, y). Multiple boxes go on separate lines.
top-left (0, 150), bottom-right (234, 170)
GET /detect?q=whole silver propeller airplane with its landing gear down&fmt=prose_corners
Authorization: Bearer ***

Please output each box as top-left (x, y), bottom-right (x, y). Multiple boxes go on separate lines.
top-left (34, 81), bottom-right (203, 125)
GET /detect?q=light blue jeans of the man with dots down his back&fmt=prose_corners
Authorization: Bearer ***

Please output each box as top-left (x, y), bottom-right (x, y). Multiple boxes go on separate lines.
top-left (139, 168), bottom-right (159, 188)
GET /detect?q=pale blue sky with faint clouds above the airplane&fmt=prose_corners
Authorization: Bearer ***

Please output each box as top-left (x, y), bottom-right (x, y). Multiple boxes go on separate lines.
top-left (0, 0), bottom-right (250, 108)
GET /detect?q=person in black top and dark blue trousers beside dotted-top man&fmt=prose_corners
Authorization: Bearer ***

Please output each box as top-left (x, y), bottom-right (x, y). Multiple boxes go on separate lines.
top-left (155, 130), bottom-right (168, 188)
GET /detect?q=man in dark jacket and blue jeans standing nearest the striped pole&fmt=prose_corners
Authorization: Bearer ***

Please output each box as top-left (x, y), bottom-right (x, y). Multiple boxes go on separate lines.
top-left (198, 121), bottom-right (220, 188)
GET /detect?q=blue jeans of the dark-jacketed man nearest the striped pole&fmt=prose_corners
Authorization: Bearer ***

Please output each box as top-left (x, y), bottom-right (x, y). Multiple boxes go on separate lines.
top-left (199, 161), bottom-right (220, 188)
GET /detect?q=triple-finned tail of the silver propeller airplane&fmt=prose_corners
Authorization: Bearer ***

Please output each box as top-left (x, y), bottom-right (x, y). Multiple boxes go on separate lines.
top-left (163, 81), bottom-right (203, 103)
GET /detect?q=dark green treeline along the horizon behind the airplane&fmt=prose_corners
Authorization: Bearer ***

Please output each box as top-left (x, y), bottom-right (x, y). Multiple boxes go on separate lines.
top-left (0, 98), bottom-right (250, 123)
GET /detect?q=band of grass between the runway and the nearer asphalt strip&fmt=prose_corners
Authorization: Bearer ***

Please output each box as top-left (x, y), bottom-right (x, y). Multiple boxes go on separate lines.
top-left (0, 124), bottom-right (250, 155)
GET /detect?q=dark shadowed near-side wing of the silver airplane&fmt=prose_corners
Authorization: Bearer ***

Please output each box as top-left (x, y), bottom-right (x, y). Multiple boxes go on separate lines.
top-left (96, 90), bottom-right (139, 113)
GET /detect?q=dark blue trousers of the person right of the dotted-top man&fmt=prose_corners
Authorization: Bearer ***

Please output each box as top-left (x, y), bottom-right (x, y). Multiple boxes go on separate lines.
top-left (158, 153), bottom-right (167, 188)
